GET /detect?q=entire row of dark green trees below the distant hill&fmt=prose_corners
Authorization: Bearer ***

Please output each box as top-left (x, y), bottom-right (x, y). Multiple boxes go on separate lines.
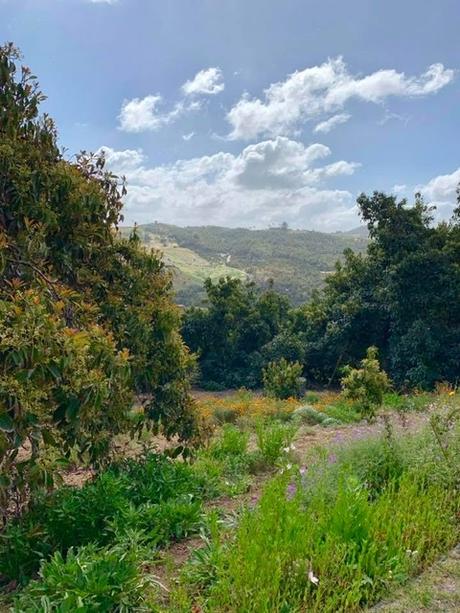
top-left (183, 192), bottom-right (460, 389)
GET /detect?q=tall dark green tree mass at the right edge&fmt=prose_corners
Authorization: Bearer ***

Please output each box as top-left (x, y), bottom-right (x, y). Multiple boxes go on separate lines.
top-left (292, 192), bottom-right (460, 388)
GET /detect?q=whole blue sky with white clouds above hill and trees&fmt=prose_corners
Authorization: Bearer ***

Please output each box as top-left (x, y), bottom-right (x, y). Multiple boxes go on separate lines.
top-left (0, 0), bottom-right (460, 232)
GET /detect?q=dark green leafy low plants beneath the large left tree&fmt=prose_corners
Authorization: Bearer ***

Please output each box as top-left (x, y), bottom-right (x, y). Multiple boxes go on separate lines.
top-left (0, 454), bottom-right (206, 583)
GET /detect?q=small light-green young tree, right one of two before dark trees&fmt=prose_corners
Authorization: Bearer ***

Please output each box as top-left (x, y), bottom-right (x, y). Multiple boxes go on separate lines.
top-left (341, 347), bottom-right (390, 420)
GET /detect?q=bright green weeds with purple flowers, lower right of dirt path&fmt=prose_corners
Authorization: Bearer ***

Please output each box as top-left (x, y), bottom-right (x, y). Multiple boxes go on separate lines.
top-left (170, 394), bottom-right (460, 612)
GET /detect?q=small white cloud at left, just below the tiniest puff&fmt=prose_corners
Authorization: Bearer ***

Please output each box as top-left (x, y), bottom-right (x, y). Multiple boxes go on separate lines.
top-left (118, 94), bottom-right (201, 132)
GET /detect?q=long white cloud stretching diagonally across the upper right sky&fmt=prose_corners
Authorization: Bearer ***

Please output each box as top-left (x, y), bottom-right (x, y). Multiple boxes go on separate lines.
top-left (227, 57), bottom-right (454, 140)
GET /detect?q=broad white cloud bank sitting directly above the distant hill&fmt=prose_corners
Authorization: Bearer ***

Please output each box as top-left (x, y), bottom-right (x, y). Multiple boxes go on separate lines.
top-left (99, 137), bottom-right (358, 231)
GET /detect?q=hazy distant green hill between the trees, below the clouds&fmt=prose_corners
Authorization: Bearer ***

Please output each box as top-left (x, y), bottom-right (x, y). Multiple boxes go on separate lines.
top-left (121, 223), bottom-right (368, 305)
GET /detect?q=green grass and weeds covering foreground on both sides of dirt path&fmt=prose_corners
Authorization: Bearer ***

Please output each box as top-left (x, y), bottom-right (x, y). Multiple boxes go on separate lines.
top-left (0, 391), bottom-right (460, 613)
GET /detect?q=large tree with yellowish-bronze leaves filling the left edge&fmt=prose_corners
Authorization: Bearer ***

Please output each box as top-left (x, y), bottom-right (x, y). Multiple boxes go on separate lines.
top-left (0, 45), bottom-right (193, 515)
